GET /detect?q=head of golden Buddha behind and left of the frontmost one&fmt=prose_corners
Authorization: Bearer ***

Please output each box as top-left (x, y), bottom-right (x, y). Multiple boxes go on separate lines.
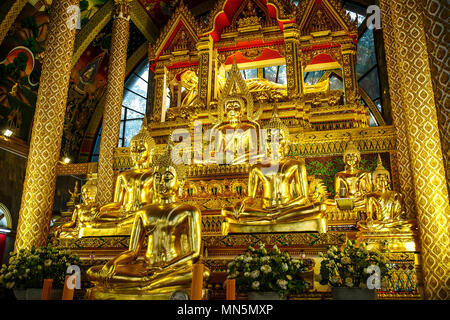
top-left (130, 117), bottom-right (155, 168)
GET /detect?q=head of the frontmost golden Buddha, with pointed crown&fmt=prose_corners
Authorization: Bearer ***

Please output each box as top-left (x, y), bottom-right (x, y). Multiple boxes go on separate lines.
top-left (153, 145), bottom-right (185, 199)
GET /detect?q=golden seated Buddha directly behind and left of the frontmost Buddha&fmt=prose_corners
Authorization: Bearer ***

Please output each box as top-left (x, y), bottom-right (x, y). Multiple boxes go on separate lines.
top-left (80, 118), bottom-right (155, 237)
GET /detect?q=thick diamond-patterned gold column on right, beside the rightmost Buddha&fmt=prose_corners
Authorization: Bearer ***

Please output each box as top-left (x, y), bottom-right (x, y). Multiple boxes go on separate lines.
top-left (380, 0), bottom-right (450, 299)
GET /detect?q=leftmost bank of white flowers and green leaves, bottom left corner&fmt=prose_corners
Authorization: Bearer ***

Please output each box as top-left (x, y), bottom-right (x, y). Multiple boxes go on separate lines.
top-left (0, 245), bottom-right (80, 289)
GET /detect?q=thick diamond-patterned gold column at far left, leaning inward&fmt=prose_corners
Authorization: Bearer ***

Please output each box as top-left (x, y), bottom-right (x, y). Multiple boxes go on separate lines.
top-left (15, 0), bottom-right (78, 251)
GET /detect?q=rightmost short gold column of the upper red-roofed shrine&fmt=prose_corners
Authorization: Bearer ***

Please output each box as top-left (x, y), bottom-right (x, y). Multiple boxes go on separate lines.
top-left (342, 43), bottom-right (359, 105)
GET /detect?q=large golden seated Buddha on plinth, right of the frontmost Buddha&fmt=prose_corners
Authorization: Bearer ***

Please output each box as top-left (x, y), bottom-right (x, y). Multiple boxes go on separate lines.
top-left (222, 110), bottom-right (327, 234)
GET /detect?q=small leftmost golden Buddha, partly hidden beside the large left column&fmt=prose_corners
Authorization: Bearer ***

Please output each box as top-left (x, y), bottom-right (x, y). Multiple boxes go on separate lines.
top-left (54, 177), bottom-right (98, 238)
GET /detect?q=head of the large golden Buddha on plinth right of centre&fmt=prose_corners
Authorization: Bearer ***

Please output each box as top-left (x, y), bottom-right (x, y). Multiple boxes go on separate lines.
top-left (263, 107), bottom-right (289, 157)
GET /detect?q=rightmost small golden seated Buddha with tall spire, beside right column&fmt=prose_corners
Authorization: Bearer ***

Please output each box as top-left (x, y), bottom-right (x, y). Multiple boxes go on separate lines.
top-left (358, 155), bottom-right (414, 232)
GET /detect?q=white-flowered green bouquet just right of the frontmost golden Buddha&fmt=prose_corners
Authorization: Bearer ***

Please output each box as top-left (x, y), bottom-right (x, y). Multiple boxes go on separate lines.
top-left (227, 244), bottom-right (308, 294)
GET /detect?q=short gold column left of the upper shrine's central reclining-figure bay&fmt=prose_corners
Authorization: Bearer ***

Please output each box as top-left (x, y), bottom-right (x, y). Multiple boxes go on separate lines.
top-left (197, 35), bottom-right (213, 108)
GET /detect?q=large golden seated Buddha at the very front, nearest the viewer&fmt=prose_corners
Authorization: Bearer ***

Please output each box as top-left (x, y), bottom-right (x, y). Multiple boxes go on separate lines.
top-left (87, 148), bottom-right (209, 299)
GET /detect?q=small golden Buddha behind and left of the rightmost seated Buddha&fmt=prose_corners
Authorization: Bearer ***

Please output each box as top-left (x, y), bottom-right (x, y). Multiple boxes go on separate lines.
top-left (334, 141), bottom-right (372, 211)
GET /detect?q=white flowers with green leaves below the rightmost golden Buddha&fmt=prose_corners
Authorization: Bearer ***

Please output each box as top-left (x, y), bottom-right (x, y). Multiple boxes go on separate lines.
top-left (319, 240), bottom-right (389, 288)
